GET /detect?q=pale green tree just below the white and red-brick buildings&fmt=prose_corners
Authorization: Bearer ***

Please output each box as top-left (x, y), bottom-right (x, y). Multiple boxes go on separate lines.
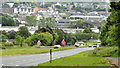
top-left (25, 15), bottom-right (37, 26)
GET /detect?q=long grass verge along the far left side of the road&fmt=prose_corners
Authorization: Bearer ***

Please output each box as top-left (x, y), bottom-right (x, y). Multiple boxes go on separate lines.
top-left (2, 46), bottom-right (86, 56)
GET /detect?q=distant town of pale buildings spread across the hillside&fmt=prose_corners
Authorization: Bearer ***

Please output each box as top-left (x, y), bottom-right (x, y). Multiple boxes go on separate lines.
top-left (0, 2), bottom-right (110, 34)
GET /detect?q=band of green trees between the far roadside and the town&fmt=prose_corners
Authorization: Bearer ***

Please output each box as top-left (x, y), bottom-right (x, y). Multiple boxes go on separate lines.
top-left (1, 26), bottom-right (99, 47)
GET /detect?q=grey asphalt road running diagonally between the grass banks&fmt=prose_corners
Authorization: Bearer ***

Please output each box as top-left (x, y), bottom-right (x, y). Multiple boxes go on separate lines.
top-left (2, 47), bottom-right (93, 66)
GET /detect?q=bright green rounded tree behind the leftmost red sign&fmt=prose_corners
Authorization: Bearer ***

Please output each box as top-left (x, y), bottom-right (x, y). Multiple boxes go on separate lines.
top-left (25, 32), bottom-right (53, 46)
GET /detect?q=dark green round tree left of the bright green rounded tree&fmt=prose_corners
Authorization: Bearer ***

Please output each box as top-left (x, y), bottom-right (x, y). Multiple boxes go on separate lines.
top-left (18, 26), bottom-right (31, 38)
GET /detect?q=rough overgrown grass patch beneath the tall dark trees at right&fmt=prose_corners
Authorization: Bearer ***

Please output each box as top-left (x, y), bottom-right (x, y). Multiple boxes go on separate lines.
top-left (96, 47), bottom-right (120, 57)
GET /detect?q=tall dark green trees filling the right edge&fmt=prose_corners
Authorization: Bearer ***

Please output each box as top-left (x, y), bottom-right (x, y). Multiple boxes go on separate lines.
top-left (100, 1), bottom-right (120, 46)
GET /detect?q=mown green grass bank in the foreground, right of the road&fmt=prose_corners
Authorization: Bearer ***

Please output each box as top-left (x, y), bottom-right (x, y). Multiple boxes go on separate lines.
top-left (31, 50), bottom-right (110, 68)
